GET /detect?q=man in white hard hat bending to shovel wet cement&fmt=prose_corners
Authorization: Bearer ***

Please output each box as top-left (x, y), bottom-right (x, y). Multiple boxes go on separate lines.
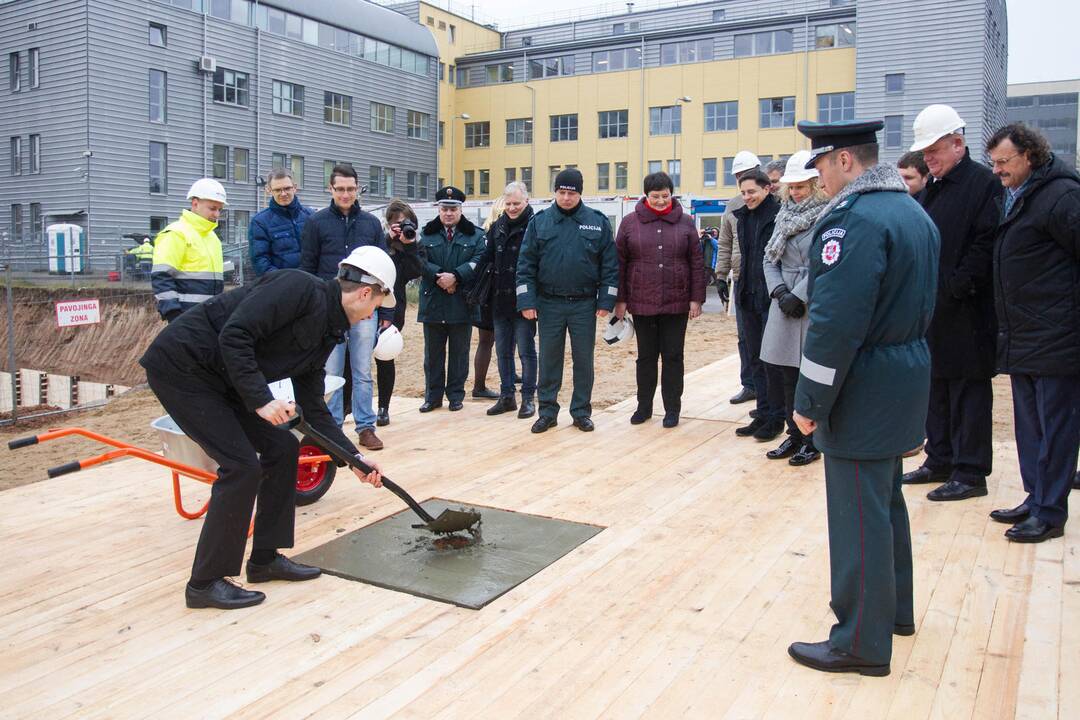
top-left (139, 246), bottom-right (396, 610)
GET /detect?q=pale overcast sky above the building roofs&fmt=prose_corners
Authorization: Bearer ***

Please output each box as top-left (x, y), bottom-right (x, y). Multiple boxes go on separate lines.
top-left (432, 0), bottom-right (1080, 82)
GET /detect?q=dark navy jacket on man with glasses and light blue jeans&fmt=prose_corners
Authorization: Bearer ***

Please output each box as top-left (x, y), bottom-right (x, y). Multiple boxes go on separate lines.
top-left (299, 203), bottom-right (394, 321)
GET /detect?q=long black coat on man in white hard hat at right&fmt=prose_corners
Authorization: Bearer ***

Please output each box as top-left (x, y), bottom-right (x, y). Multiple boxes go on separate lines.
top-left (919, 152), bottom-right (1001, 379)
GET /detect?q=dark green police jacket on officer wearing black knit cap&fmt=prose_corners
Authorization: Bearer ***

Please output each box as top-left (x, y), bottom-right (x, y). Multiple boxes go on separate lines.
top-left (516, 203), bottom-right (619, 311)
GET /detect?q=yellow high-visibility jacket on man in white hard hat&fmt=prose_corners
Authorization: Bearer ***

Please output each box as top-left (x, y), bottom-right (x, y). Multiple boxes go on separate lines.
top-left (150, 210), bottom-right (225, 320)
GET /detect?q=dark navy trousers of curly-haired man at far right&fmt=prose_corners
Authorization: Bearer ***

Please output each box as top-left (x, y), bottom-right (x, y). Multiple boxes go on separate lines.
top-left (1011, 375), bottom-right (1080, 527)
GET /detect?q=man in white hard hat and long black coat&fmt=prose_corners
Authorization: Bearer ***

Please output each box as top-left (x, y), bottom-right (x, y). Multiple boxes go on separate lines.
top-left (904, 105), bottom-right (1001, 502)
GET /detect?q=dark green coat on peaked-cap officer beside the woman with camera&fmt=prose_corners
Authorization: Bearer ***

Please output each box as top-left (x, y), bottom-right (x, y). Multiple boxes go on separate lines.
top-left (417, 217), bottom-right (486, 323)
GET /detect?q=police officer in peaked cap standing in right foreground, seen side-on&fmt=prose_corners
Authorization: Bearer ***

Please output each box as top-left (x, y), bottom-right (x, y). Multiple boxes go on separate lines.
top-left (788, 121), bottom-right (940, 676)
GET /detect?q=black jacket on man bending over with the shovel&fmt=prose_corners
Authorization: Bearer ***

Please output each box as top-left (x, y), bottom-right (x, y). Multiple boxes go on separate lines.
top-left (139, 270), bottom-right (356, 462)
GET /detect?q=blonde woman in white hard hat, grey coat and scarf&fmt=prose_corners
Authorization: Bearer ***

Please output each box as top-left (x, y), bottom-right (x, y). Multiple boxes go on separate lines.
top-left (760, 150), bottom-right (828, 465)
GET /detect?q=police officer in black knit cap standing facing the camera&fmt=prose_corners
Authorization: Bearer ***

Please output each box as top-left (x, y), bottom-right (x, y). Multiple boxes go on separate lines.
top-left (516, 168), bottom-right (619, 433)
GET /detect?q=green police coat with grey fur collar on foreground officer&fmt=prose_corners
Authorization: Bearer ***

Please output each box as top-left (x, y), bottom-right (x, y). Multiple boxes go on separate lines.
top-left (795, 165), bottom-right (941, 460)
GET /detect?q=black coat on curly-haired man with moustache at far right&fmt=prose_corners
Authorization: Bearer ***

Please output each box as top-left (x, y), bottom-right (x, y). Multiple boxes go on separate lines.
top-left (994, 158), bottom-right (1080, 376)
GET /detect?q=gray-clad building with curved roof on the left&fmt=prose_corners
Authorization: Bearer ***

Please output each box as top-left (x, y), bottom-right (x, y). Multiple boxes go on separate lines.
top-left (0, 0), bottom-right (438, 260)
